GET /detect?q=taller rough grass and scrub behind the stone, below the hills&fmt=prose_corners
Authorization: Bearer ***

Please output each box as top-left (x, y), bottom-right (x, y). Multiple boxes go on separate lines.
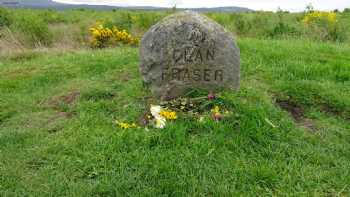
top-left (0, 8), bottom-right (350, 52)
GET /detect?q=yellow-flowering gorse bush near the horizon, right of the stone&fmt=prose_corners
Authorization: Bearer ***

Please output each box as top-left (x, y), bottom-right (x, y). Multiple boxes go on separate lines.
top-left (303, 11), bottom-right (338, 25)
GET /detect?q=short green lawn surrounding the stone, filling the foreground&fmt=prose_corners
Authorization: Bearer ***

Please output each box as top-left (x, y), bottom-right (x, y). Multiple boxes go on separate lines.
top-left (0, 39), bottom-right (350, 196)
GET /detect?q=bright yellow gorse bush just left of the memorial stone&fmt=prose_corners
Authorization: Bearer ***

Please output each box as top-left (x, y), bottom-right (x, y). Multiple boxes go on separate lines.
top-left (90, 22), bottom-right (140, 48)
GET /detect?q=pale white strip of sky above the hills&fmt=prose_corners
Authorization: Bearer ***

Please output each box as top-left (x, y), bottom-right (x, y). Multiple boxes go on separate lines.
top-left (53, 0), bottom-right (350, 12)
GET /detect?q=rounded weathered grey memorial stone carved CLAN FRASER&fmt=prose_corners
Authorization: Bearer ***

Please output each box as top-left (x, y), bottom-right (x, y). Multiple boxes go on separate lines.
top-left (140, 11), bottom-right (240, 99)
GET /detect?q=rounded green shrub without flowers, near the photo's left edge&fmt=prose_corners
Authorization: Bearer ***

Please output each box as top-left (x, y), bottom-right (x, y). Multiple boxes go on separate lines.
top-left (11, 13), bottom-right (53, 47)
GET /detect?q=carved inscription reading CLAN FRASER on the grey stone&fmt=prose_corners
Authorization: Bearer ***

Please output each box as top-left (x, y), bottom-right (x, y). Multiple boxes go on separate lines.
top-left (162, 23), bottom-right (224, 82)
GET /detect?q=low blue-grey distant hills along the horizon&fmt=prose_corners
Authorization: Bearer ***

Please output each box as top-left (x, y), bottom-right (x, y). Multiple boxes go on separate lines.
top-left (0, 0), bottom-right (253, 12)
